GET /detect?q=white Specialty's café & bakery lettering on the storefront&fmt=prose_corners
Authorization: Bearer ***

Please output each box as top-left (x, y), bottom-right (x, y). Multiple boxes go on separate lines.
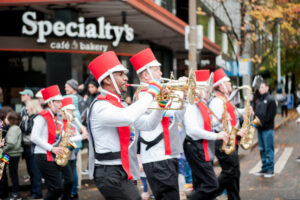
top-left (22, 11), bottom-right (134, 49)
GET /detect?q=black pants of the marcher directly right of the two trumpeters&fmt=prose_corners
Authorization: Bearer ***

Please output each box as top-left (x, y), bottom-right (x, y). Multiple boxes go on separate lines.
top-left (183, 140), bottom-right (218, 200)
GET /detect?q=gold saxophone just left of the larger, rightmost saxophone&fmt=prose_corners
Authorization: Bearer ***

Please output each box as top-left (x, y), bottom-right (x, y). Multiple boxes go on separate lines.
top-left (221, 98), bottom-right (238, 155)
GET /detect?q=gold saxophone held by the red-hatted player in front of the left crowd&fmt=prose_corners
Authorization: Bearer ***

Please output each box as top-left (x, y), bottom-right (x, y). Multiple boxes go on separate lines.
top-left (55, 111), bottom-right (76, 167)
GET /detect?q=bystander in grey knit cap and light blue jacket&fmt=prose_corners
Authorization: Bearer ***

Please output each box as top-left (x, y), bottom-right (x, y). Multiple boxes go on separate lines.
top-left (65, 79), bottom-right (86, 115)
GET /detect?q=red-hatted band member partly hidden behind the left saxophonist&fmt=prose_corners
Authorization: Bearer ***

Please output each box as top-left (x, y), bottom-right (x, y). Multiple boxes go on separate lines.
top-left (61, 97), bottom-right (88, 199)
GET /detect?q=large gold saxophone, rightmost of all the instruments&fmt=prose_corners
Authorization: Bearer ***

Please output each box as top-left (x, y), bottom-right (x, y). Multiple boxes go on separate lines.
top-left (238, 85), bottom-right (260, 150)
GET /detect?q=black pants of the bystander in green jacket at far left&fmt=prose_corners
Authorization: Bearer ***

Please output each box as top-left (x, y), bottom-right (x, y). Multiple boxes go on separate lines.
top-left (8, 156), bottom-right (20, 193)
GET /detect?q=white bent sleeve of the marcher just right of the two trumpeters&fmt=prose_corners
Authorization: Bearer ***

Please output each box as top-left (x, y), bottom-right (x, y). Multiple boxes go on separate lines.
top-left (184, 104), bottom-right (217, 140)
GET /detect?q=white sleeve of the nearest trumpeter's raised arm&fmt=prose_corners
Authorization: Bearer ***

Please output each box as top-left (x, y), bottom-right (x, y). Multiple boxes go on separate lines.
top-left (92, 93), bottom-right (153, 127)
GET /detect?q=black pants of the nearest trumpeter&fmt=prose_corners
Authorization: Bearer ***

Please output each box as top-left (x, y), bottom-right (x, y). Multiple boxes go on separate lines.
top-left (94, 165), bottom-right (141, 200)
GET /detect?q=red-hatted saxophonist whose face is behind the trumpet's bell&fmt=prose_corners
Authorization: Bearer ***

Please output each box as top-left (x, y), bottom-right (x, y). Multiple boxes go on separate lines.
top-left (183, 70), bottom-right (229, 200)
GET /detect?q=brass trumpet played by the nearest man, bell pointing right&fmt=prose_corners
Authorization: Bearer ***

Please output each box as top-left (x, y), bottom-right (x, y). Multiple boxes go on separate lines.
top-left (127, 70), bottom-right (196, 110)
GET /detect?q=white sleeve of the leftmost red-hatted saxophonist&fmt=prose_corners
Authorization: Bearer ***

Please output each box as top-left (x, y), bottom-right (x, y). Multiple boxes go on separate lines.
top-left (30, 115), bottom-right (53, 151)
